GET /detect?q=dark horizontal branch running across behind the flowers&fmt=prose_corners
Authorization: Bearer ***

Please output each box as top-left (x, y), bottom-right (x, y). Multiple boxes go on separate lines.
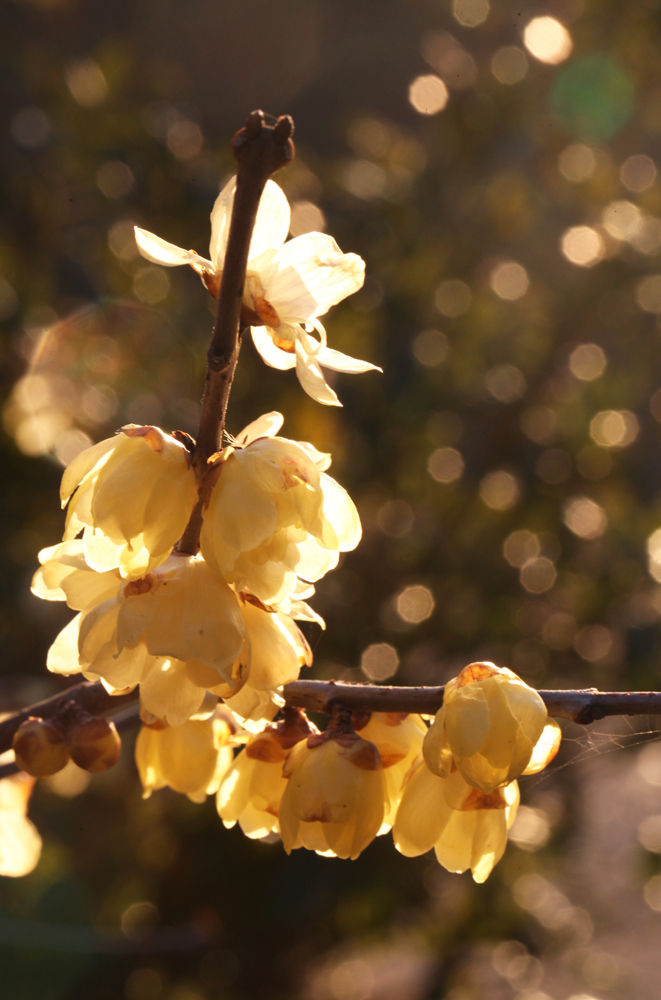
top-left (0, 681), bottom-right (661, 774)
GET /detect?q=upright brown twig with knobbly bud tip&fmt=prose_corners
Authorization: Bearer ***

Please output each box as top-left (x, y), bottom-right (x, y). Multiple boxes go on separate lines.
top-left (178, 111), bottom-right (294, 555)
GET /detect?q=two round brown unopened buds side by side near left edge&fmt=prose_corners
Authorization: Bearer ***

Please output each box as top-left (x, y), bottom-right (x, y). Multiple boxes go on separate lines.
top-left (12, 702), bottom-right (122, 778)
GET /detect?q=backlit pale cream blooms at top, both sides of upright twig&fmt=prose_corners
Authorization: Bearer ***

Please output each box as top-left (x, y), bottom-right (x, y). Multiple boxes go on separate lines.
top-left (135, 178), bottom-right (381, 406)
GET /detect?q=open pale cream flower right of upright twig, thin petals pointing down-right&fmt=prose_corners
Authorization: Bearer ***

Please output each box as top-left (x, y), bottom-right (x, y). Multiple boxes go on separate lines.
top-left (243, 233), bottom-right (381, 406)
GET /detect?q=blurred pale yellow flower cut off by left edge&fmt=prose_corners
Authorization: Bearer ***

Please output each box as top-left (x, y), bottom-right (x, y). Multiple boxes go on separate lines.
top-left (0, 750), bottom-right (41, 878)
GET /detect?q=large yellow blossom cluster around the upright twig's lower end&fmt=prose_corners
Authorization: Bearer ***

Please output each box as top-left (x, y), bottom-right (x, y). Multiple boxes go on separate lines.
top-left (33, 413), bottom-right (361, 727)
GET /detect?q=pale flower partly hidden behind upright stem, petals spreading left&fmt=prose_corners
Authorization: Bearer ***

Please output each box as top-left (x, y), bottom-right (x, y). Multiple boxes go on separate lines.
top-left (135, 177), bottom-right (290, 298)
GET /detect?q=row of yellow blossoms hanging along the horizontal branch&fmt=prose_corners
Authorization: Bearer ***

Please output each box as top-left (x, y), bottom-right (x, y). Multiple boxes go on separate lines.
top-left (137, 663), bottom-right (560, 882)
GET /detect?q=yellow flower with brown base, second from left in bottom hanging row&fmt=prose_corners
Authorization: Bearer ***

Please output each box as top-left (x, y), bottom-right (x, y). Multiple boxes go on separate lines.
top-left (216, 708), bottom-right (317, 838)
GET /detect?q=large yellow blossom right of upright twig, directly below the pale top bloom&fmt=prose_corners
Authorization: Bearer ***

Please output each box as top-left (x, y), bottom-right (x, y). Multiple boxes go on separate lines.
top-left (200, 413), bottom-right (361, 604)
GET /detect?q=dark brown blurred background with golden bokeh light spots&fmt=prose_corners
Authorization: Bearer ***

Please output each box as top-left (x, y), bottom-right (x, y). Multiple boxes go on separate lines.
top-left (6, 0), bottom-right (661, 1000)
